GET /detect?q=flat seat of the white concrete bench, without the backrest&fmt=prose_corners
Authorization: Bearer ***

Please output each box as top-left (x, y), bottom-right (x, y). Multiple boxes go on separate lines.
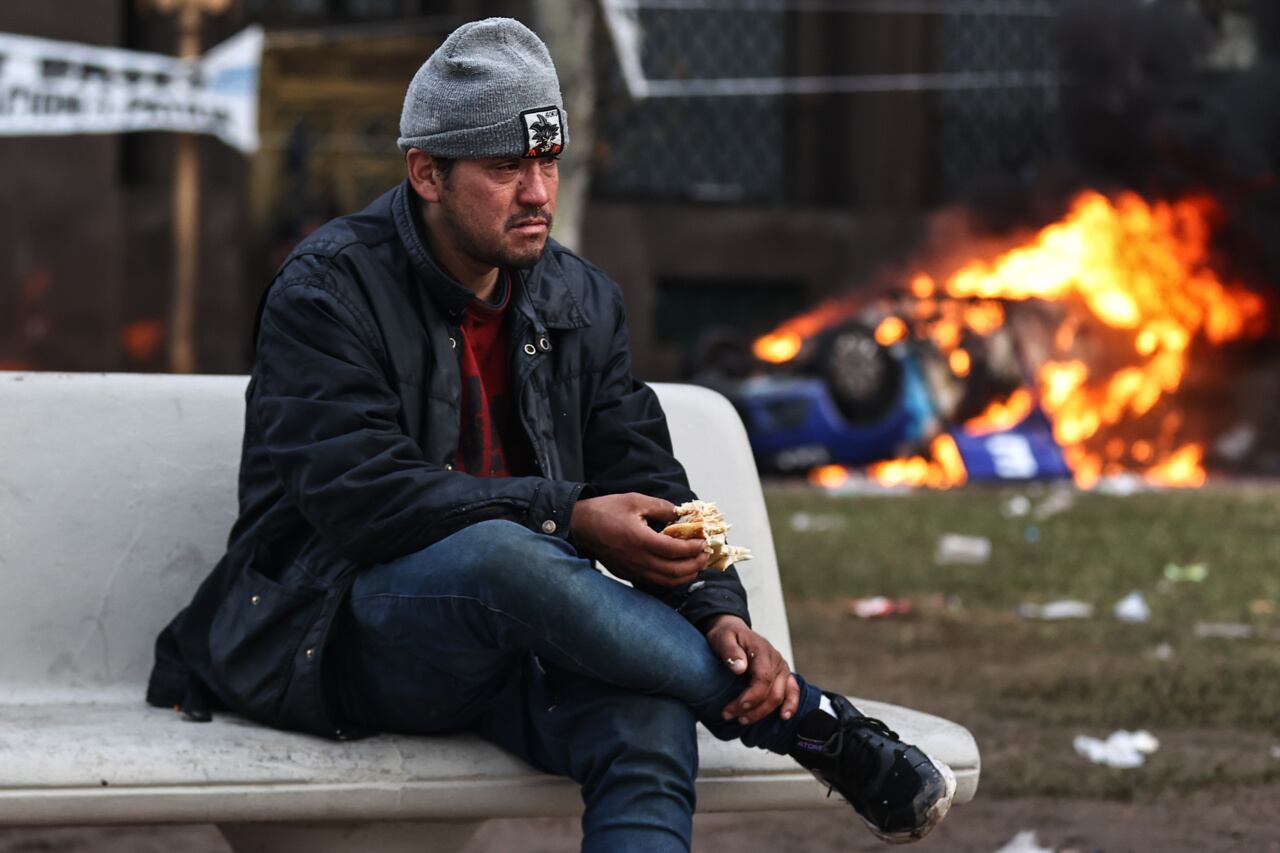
top-left (0, 702), bottom-right (977, 825)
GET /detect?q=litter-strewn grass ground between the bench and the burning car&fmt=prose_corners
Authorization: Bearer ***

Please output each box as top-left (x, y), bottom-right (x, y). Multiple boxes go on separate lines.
top-left (767, 485), bottom-right (1280, 799)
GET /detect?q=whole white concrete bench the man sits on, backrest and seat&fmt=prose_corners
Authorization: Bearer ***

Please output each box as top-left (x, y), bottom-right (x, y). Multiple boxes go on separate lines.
top-left (0, 373), bottom-right (978, 853)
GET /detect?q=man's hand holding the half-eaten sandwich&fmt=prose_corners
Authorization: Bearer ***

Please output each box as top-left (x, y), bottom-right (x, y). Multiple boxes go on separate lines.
top-left (570, 492), bottom-right (708, 587)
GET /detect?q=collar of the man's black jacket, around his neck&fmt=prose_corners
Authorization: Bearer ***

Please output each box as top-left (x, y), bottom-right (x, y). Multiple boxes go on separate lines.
top-left (392, 179), bottom-right (590, 330)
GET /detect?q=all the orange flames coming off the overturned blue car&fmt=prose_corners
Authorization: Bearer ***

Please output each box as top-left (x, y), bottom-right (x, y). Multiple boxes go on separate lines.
top-left (755, 191), bottom-right (1266, 488)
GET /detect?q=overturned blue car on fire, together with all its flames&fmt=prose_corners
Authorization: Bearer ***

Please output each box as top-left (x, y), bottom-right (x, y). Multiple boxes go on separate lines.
top-left (695, 192), bottom-right (1267, 487)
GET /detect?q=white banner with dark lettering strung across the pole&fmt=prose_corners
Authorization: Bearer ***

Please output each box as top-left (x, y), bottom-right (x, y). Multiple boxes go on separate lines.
top-left (0, 27), bottom-right (264, 154)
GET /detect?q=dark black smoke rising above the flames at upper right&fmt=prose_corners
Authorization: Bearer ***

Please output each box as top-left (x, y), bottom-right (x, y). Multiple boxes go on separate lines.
top-left (963, 0), bottom-right (1280, 298)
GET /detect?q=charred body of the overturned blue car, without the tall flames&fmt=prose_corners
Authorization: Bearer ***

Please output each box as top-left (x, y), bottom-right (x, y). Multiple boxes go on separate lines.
top-left (696, 301), bottom-right (1070, 487)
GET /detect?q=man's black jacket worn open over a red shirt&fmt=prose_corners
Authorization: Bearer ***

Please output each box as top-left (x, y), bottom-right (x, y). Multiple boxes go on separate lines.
top-left (147, 182), bottom-right (748, 736)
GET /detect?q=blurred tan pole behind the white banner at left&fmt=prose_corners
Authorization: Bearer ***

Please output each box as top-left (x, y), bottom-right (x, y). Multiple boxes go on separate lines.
top-left (169, 3), bottom-right (200, 373)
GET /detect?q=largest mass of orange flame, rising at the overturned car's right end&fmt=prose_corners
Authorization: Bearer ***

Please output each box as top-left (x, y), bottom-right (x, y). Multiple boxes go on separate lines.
top-left (943, 192), bottom-right (1265, 485)
